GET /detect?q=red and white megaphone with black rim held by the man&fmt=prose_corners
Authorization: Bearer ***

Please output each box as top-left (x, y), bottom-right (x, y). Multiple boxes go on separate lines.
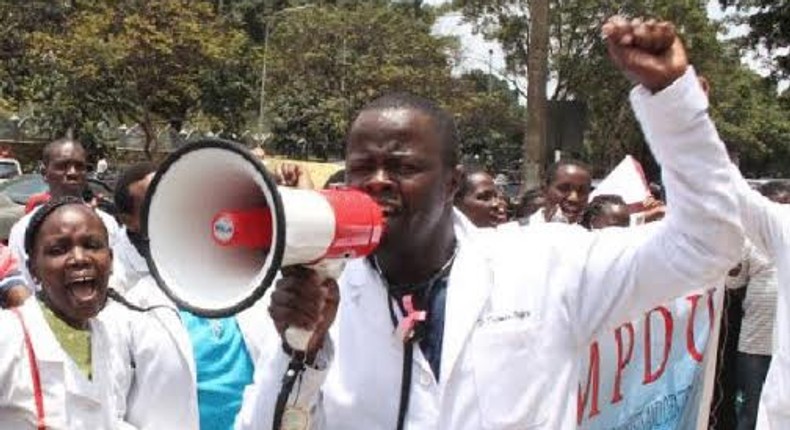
top-left (141, 139), bottom-right (384, 350)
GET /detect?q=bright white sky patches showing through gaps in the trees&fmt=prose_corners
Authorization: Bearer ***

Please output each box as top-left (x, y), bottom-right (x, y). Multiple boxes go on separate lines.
top-left (425, 0), bottom-right (788, 94)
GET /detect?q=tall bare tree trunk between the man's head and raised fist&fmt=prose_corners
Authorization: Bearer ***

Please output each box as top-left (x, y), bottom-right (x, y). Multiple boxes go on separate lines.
top-left (522, 0), bottom-right (549, 189)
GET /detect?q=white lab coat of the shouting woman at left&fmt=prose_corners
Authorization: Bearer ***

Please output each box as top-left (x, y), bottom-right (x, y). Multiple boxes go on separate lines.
top-left (0, 299), bottom-right (133, 430)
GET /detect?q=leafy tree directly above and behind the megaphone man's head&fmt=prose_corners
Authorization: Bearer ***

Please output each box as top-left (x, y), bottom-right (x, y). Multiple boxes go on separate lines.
top-left (266, 2), bottom-right (454, 158)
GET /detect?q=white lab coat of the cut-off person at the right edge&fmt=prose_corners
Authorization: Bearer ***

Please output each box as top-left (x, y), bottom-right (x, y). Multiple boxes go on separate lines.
top-left (732, 170), bottom-right (790, 430)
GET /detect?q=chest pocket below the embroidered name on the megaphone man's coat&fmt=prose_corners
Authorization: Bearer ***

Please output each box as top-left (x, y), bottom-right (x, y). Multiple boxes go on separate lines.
top-left (471, 321), bottom-right (546, 430)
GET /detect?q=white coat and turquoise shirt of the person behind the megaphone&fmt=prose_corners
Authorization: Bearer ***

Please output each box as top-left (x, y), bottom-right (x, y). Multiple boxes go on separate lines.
top-left (126, 276), bottom-right (280, 430)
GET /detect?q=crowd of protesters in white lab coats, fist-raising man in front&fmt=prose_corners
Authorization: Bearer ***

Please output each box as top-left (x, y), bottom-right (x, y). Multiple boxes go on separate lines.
top-left (0, 13), bottom-right (790, 430)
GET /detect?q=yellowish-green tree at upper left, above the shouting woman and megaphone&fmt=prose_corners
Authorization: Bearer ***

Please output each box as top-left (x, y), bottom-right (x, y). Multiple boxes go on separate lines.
top-left (10, 0), bottom-right (255, 156)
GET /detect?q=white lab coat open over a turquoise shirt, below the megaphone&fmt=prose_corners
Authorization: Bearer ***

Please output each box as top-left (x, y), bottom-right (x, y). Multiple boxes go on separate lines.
top-left (126, 276), bottom-right (272, 430)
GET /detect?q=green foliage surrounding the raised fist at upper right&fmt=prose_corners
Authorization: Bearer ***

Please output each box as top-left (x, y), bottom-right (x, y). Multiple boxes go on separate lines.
top-left (455, 0), bottom-right (790, 175)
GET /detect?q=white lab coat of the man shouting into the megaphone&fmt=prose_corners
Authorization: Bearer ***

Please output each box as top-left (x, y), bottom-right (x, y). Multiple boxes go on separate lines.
top-left (237, 70), bottom-right (743, 430)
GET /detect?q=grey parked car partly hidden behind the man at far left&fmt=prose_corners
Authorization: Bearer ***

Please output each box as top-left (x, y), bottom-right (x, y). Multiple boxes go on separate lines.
top-left (0, 173), bottom-right (115, 243)
